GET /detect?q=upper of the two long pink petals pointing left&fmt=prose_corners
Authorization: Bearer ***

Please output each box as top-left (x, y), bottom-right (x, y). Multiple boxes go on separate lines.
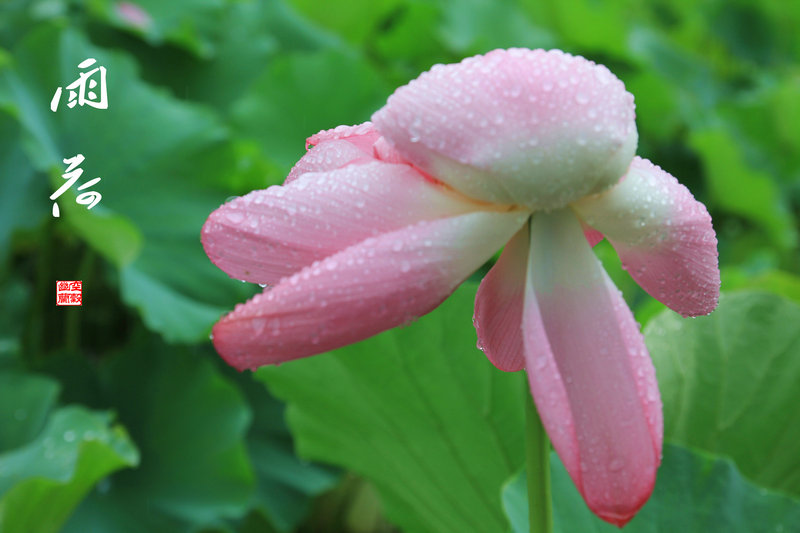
top-left (201, 161), bottom-right (480, 285)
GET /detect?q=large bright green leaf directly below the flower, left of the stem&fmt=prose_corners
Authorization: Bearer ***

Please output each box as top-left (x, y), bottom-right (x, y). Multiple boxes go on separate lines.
top-left (257, 284), bottom-right (525, 533)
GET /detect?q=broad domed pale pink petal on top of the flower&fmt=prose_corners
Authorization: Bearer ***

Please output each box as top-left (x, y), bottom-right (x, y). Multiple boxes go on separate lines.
top-left (372, 49), bottom-right (638, 209)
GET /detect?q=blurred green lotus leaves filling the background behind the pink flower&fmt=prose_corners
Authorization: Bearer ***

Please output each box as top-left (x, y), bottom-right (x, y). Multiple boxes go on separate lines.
top-left (0, 0), bottom-right (800, 533)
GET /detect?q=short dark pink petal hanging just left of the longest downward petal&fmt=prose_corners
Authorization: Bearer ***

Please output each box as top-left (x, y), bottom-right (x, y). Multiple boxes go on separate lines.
top-left (473, 224), bottom-right (530, 372)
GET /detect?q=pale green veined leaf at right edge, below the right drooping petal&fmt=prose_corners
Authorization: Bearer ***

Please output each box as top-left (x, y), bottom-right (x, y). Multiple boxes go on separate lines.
top-left (645, 291), bottom-right (800, 496)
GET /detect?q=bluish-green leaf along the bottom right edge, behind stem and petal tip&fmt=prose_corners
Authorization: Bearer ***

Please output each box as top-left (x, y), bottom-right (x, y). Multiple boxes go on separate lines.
top-left (503, 445), bottom-right (800, 533)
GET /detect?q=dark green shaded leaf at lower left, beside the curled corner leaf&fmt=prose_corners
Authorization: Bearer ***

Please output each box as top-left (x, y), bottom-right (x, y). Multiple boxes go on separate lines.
top-left (65, 340), bottom-right (255, 533)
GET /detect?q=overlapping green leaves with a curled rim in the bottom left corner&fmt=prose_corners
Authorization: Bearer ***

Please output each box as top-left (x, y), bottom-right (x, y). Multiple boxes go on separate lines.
top-left (0, 382), bottom-right (139, 533)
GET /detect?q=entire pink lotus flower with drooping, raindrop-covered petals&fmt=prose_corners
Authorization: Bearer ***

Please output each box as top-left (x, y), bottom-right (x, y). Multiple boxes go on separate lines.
top-left (202, 49), bottom-right (719, 526)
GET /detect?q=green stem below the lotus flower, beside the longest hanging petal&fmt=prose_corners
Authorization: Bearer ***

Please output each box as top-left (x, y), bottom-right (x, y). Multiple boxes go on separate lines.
top-left (524, 379), bottom-right (553, 533)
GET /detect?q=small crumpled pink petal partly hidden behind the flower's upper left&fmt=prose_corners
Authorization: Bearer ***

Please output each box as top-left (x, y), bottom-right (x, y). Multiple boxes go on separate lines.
top-left (284, 122), bottom-right (380, 185)
